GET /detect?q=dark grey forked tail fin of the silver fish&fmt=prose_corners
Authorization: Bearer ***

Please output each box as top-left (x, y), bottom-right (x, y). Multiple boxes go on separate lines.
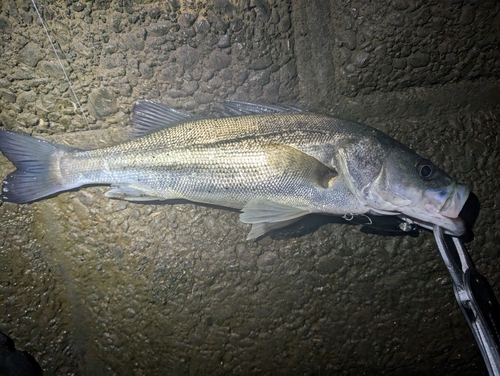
top-left (0, 129), bottom-right (77, 204)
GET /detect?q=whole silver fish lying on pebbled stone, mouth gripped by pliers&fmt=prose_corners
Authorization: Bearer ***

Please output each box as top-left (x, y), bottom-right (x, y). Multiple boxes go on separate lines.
top-left (0, 100), bottom-right (470, 239)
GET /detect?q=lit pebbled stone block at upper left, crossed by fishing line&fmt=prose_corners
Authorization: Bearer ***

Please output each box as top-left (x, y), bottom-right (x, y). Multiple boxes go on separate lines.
top-left (0, 1), bottom-right (297, 133)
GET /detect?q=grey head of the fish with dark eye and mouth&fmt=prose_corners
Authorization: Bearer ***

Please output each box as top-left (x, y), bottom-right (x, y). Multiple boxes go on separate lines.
top-left (343, 138), bottom-right (469, 236)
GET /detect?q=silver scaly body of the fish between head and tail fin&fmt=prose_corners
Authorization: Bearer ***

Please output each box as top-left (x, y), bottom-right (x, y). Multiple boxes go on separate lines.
top-left (64, 113), bottom-right (366, 214)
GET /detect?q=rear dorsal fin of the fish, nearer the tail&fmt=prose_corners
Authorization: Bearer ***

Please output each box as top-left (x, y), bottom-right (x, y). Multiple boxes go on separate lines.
top-left (130, 99), bottom-right (200, 138)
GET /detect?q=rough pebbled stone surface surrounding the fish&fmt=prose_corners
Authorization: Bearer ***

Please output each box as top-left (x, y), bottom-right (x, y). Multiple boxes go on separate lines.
top-left (0, 0), bottom-right (500, 375)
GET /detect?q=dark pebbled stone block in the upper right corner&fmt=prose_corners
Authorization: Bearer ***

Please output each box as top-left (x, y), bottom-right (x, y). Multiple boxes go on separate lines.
top-left (331, 1), bottom-right (500, 95)
